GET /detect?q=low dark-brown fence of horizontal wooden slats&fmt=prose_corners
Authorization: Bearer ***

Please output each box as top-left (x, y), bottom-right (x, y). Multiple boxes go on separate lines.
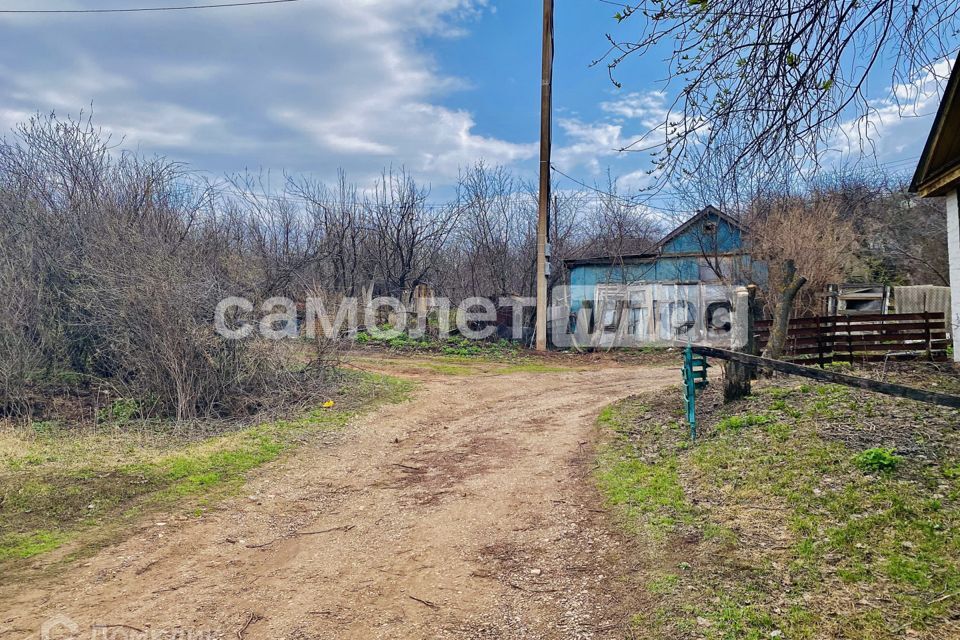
top-left (755, 313), bottom-right (950, 364)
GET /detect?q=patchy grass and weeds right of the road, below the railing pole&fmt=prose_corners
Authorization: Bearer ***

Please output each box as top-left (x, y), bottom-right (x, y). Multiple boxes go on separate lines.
top-left (597, 372), bottom-right (960, 640)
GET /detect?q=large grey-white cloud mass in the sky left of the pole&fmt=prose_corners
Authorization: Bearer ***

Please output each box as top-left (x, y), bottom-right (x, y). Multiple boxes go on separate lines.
top-left (0, 0), bottom-right (536, 182)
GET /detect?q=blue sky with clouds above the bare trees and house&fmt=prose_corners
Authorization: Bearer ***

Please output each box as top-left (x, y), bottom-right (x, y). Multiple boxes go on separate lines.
top-left (0, 0), bottom-right (937, 197)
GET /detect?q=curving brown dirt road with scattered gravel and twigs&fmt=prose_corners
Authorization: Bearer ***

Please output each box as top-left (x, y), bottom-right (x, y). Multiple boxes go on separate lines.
top-left (0, 365), bottom-right (677, 640)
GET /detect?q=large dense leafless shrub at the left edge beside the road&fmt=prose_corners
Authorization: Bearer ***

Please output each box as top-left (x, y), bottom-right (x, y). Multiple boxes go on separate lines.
top-left (0, 116), bottom-right (342, 420)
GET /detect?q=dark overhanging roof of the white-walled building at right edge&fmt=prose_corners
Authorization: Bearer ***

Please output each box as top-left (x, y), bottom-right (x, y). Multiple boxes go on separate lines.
top-left (910, 58), bottom-right (960, 197)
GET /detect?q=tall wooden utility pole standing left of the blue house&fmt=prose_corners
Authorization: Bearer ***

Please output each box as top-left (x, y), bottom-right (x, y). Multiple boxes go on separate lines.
top-left (537, 0), bottom-right (553, 351)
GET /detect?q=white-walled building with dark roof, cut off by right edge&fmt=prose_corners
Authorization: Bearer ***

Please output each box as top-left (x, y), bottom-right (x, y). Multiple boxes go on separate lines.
top-left (910, 54), bottom-right (960, 362)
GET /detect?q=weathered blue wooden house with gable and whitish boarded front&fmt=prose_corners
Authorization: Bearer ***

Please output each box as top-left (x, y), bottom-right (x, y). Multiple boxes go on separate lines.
top-left (566, 207), bottom-right (754, 346)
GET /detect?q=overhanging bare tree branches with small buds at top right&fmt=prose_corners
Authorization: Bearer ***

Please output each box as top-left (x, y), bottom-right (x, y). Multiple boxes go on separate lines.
top-left (597, 0), bottom-right (960, 186)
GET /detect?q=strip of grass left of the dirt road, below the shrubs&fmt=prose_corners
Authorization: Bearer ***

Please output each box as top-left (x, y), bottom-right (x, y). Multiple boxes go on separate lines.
top-left (0, 375), bottom-right (413, 561)
